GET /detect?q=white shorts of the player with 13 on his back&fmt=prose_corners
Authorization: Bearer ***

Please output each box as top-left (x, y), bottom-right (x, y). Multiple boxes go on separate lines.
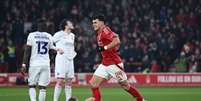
top-left (28, 66), bottom-right (50, 86)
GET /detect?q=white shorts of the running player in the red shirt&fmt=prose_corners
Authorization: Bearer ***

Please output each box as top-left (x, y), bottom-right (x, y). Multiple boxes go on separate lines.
top-left (94, 63), bottom-right (127, 82)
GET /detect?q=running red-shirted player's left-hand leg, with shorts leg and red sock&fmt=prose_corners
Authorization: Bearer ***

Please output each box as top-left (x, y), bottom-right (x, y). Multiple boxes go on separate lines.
top-left (90, 64), bottom-right (108, 101)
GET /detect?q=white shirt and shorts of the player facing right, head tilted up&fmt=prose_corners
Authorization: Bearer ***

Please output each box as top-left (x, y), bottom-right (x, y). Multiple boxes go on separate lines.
top-left (53, 31), bottom-right (77, 79)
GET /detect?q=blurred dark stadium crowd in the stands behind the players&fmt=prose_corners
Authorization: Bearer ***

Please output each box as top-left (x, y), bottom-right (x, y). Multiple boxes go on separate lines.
top-left (0, 0), bottom-right (201, 73)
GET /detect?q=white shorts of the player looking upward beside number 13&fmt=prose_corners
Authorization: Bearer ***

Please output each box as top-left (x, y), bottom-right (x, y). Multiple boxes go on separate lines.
top-left (55, 55), bottom-right (74, 79)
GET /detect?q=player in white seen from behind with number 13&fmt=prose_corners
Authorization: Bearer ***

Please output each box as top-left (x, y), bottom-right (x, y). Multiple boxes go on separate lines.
top-left (21, 20), bottom-right (63, 101)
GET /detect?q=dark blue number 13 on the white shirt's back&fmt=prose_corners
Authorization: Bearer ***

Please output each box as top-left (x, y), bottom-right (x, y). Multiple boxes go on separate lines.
top-left (36, 41), bottom-right (48, 54)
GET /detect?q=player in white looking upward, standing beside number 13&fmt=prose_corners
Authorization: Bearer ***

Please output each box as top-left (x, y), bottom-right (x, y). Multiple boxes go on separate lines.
top-left (53, 19), bottom-right (76, 101)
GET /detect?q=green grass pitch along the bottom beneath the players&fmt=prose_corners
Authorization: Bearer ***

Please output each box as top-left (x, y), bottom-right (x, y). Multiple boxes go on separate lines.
top-left (0, 87), bottom-right (201, 101)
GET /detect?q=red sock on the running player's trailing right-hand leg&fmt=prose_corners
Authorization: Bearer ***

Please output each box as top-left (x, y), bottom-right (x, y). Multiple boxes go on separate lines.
top-left (128, 86), bottom-right (143, 101)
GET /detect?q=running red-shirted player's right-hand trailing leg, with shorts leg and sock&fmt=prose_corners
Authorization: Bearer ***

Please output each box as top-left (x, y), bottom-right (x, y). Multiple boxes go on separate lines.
top-left (107, 63), bottom-right (143, 101)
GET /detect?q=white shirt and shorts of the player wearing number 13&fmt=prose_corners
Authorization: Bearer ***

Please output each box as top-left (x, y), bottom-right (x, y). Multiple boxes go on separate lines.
top-left (27, 31), bottom-right (55, 86)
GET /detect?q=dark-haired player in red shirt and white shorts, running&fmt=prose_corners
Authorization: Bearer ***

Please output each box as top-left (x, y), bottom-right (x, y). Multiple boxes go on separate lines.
top-left (86, 14), bottom-right (144, 101)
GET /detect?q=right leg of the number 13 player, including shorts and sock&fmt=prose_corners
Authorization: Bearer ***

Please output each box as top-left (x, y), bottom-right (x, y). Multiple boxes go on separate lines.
top-left (38, 66), bottom-right (50, 101)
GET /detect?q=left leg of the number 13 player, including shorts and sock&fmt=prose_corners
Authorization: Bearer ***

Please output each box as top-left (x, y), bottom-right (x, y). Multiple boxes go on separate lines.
top-left (28, 67), bottom-right (40, 101)
